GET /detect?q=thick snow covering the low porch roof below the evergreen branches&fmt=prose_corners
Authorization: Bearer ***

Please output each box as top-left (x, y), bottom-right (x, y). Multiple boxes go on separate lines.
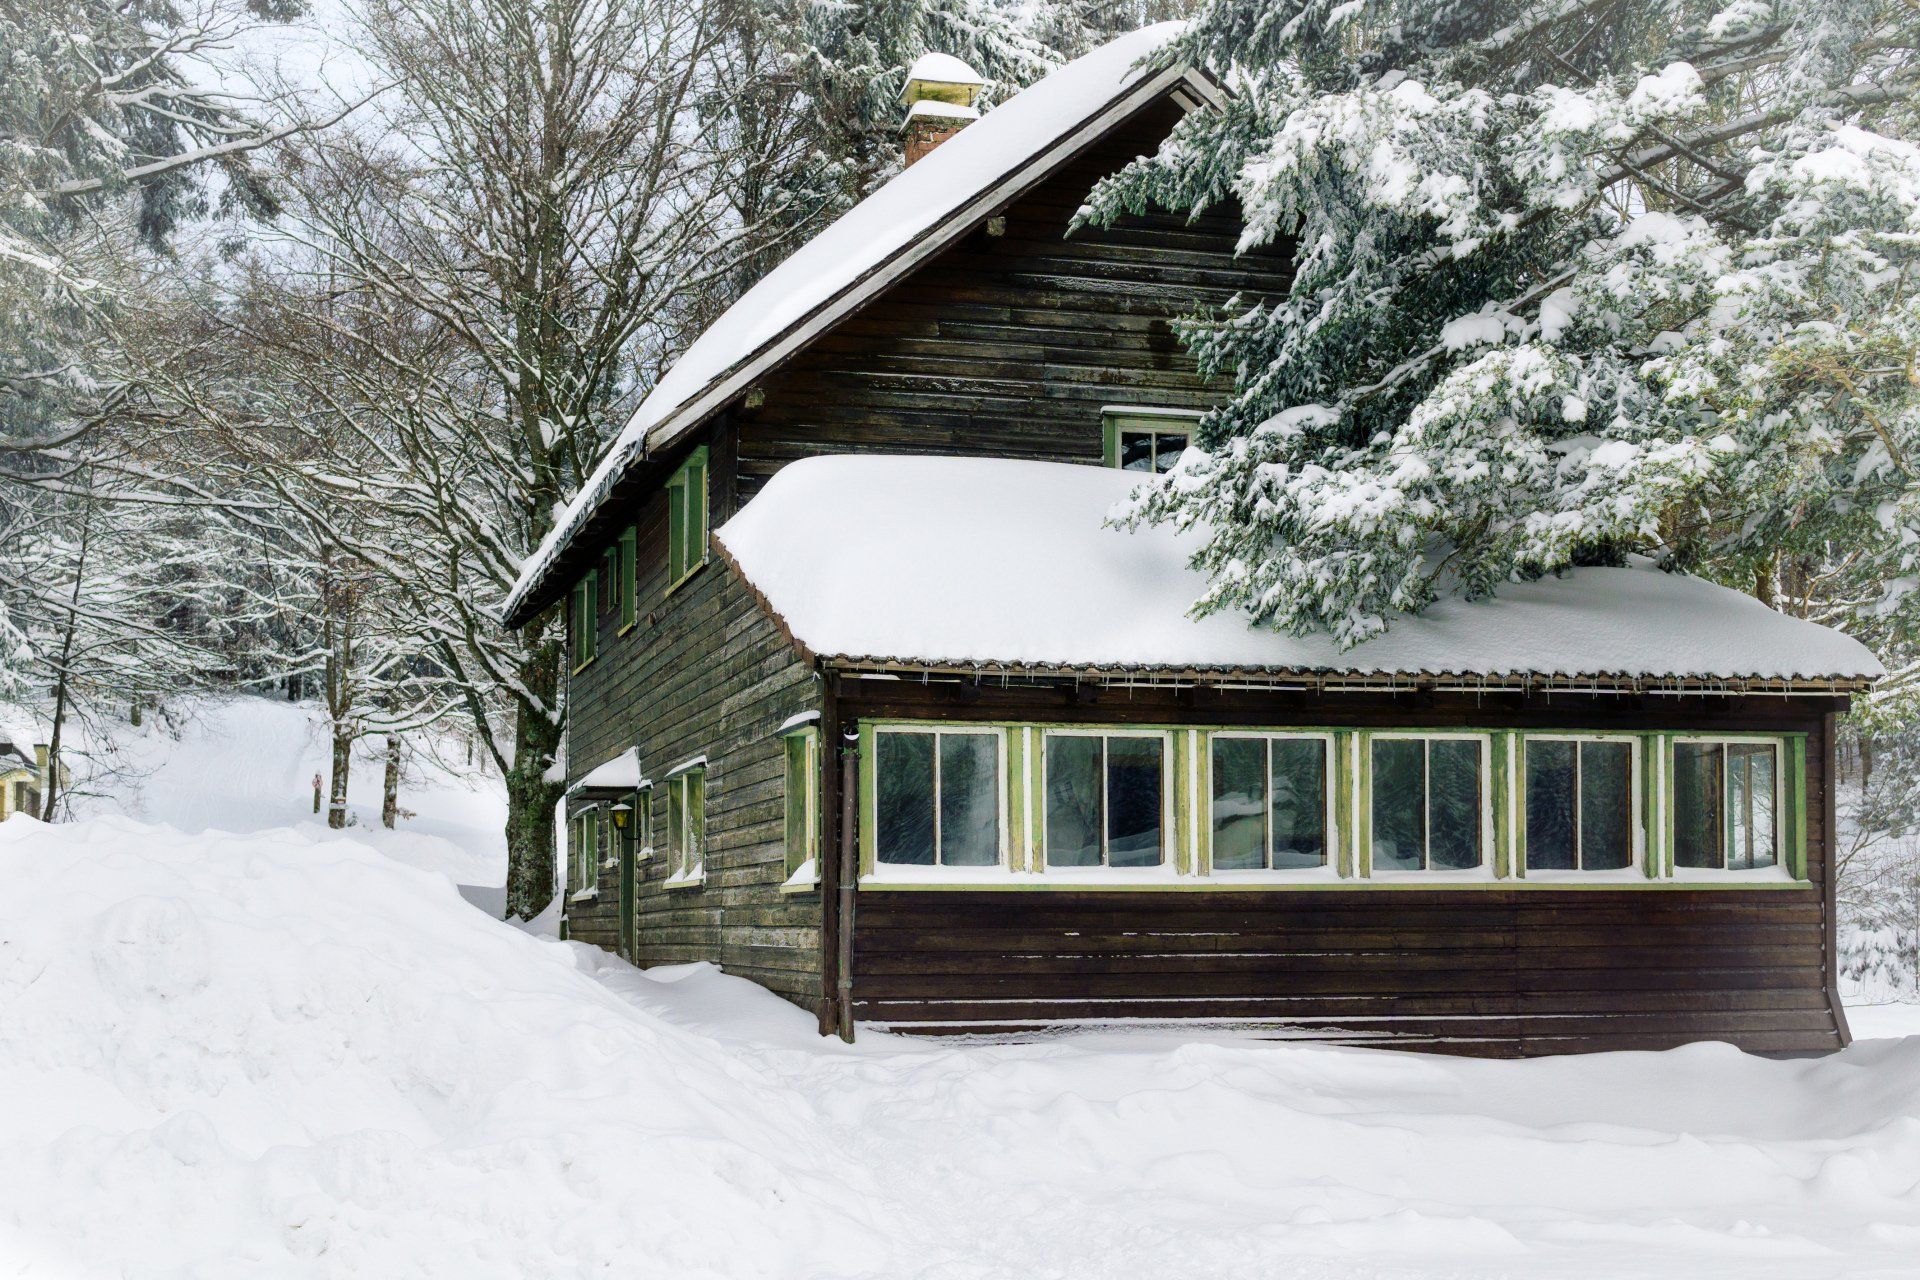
top-left (716, 455), bottom-right (1884, 681)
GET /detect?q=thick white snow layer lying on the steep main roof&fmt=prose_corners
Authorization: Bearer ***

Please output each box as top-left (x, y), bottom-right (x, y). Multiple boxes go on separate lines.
top-left (503, 23), bottom-right (1181, 616)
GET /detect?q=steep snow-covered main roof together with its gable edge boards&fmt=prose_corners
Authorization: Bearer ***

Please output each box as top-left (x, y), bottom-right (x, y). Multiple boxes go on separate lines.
top-left (503, 23), bottom-right (1215, 620)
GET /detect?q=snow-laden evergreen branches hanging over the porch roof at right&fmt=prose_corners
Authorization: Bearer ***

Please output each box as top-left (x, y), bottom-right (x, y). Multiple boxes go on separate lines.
top-left (1081, 0), bottom-right (1920, 702)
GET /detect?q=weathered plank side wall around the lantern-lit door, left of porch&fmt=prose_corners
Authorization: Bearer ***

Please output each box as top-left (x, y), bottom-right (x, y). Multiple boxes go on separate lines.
top-left (568, 435), bottom-right (822, 1011)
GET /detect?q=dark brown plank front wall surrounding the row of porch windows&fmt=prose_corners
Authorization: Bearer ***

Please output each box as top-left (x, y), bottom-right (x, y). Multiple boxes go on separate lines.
top-left (845, 681), bottom-right (1839, 1055)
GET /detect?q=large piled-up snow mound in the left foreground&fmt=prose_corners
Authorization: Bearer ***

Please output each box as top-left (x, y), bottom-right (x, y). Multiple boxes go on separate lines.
top-left (0, 819), bottom-right (877, 1278)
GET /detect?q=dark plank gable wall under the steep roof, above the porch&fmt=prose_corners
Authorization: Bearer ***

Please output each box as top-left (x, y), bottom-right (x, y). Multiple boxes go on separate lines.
top-left (739, 104), bottom-right (1290, 499)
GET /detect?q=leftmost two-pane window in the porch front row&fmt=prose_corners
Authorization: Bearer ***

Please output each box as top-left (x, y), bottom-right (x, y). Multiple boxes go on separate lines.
top-left (874, 729), bottom-right (1000, 867)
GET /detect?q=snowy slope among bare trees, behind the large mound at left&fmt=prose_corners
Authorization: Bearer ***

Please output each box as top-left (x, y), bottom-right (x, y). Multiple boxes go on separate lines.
top-left (75, 697), bottom-right (507, 885)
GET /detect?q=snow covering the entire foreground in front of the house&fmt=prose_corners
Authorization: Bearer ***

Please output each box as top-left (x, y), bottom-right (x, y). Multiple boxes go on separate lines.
top-left (0, 818), bottom-right (1920, 1280)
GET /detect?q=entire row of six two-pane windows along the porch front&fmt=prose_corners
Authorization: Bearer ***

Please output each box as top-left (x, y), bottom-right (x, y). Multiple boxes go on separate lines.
top-left (856, 725), bottom-right (1803, 875)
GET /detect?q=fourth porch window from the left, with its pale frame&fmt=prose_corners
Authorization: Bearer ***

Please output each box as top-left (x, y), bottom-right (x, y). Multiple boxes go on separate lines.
top-left (1361, 729), bottom-right (1494, 879)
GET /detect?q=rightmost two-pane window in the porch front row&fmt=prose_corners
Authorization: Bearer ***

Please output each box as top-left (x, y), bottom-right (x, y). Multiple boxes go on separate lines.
top-left (1674, 739), bottom-right (1780, 871)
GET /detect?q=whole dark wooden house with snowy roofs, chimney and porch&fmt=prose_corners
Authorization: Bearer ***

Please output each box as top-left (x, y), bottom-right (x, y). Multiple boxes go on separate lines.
top-left (507, 29), bottom-right (1880, 1055)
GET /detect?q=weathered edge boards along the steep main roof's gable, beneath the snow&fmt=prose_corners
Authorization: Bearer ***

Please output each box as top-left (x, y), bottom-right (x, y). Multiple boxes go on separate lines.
top-left (501, 37), bottom-right (1227, 628)
